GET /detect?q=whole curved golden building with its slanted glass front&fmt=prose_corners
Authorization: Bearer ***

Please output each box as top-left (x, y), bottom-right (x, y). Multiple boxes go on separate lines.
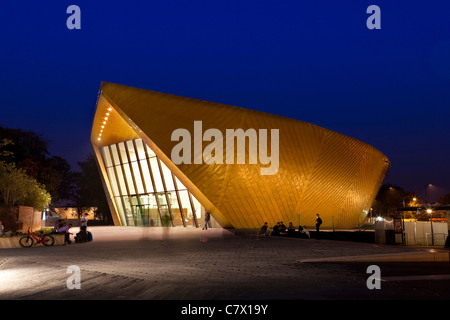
top-left (91, 82), bottom-right (390, 229)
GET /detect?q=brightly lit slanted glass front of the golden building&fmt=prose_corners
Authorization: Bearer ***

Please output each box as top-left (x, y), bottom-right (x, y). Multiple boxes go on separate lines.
top-left (100, 139), bottom-right (216, 227)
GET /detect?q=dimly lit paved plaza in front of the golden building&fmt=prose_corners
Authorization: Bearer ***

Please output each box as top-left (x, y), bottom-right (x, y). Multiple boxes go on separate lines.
top-left (0, 227), bottom-right (450, 301)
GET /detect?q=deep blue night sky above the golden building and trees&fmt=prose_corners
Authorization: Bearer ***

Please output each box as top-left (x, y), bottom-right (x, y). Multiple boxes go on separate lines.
top-left (0, 0), bottom-right (450, 200)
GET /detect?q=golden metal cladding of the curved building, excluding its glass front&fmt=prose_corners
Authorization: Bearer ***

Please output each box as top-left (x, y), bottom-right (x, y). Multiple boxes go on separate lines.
top-left (91, 82), bottom-right (390, 228)
